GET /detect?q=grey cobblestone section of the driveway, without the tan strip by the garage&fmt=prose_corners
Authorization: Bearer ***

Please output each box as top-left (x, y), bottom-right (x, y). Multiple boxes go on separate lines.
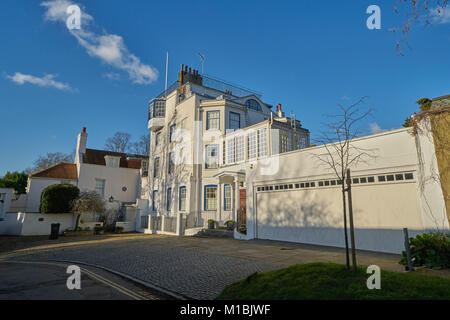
top-left (15, 237), bottom-right (283, 299)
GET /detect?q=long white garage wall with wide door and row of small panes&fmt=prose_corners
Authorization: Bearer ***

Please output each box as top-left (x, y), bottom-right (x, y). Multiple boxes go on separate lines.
top-left (246, 129), bottom-right (448, 253)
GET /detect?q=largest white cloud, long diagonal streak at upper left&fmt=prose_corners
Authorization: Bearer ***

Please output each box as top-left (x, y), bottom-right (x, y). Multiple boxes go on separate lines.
top-left (41, 0), bottom-right (158, 84)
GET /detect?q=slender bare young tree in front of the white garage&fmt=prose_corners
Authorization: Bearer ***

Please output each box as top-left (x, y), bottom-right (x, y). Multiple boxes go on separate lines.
top-left (311, 97), bottom-right (374, 269)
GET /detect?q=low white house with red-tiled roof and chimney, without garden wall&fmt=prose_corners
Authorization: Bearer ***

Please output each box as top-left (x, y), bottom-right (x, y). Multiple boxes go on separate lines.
top-left (13, 128), bottom-right (147, 212)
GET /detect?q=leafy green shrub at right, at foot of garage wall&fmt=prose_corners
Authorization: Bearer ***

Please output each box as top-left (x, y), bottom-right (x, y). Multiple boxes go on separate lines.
top-left (400, 232), bottom-right (450, 269)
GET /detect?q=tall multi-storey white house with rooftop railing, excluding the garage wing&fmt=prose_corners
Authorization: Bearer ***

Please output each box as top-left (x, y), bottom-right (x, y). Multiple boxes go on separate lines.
top-left (140, 65), bottom-right (309, 226)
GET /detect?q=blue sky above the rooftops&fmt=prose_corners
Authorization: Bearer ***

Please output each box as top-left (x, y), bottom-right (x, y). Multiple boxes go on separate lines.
top-left (0, 0), bottom-right (450, 175)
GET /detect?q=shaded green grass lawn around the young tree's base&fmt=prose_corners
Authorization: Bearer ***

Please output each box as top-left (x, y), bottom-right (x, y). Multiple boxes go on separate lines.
top-left (217, 263), bottom-right (450, 300)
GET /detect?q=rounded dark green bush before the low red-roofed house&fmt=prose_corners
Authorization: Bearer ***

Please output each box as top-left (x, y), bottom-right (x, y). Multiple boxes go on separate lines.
top-left (40, 184), bottom-right (80, 213)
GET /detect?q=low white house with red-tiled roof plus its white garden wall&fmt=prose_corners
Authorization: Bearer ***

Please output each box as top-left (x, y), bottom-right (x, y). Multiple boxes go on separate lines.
top-left (0, 128), bottom-right (148, 235)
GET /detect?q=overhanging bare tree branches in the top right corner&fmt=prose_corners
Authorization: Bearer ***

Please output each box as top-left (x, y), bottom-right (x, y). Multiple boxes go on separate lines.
top-left (391, 0), bottom-right (448, 55)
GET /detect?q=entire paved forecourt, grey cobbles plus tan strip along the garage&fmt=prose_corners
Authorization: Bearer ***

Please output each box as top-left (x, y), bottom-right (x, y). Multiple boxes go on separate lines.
top-left (3, 235), bottom-right (424, 299)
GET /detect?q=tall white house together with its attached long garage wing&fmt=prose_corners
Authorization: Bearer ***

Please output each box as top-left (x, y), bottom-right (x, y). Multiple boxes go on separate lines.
top-left (137, 66), bottom-right (450, 253)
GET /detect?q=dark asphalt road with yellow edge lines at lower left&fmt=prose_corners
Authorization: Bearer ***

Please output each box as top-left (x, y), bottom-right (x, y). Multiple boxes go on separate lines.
top-left (0, 261), bottom-right (166, 300)
